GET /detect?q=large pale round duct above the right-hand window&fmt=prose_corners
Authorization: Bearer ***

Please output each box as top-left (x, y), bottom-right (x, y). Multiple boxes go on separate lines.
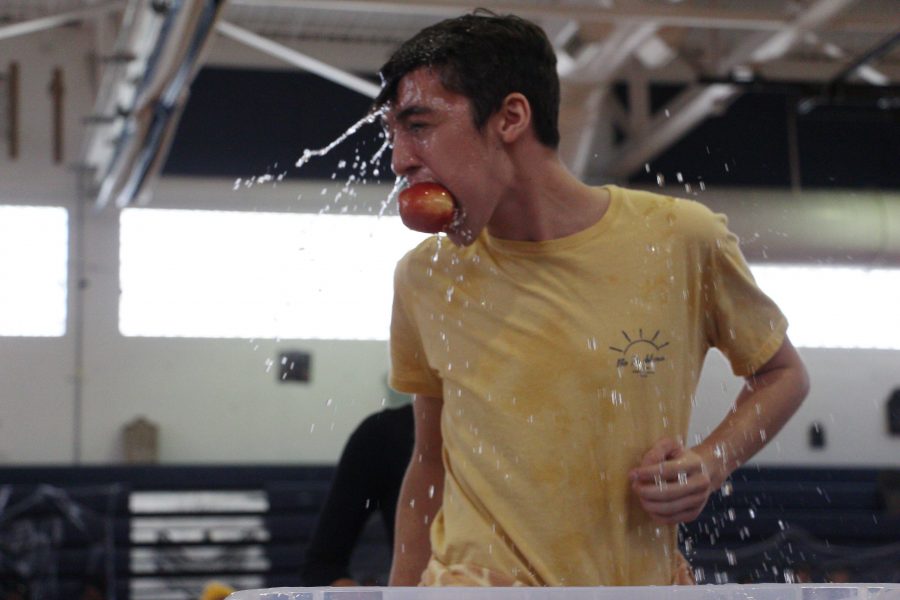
top-left (684, 189), bottom-right (900, 268)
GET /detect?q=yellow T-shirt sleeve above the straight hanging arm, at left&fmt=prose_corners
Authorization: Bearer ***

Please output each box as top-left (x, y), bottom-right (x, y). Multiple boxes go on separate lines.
top-left (388, 255), bottom-right (443, 397)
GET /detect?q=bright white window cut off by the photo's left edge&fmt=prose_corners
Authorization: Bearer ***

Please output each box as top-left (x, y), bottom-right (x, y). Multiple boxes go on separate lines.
top-left (0, 205), bottom-right (69, 337)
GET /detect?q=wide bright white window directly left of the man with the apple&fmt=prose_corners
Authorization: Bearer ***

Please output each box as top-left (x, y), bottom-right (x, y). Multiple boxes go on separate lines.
top-left (119, 208), bottom-right (425, 340)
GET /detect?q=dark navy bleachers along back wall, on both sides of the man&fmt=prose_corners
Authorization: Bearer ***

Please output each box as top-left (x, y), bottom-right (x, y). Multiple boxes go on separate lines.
top-left (0, 465), bottom-right (900, 600)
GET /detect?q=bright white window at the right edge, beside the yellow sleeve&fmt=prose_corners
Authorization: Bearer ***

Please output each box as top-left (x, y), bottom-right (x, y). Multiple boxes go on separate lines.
top-left (751, 265), bottom-right (900, 350)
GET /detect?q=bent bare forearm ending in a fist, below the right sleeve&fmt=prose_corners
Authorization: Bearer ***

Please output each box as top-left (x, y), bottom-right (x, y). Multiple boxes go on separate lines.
top-left (630, 338), bottom-right (809, 523)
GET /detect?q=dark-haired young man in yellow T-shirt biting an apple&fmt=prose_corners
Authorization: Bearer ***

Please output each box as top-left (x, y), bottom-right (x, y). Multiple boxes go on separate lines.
top-left (377, 13), bottom-right (808, 586)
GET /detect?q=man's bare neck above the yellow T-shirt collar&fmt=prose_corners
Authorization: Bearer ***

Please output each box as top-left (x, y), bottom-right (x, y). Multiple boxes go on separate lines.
top-left (488, 146), bottom-right (609, 242)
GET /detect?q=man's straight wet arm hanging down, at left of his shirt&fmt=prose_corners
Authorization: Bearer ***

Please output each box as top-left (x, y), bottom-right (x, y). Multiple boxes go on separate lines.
top-left (389, 395), bottom-right (444, 586)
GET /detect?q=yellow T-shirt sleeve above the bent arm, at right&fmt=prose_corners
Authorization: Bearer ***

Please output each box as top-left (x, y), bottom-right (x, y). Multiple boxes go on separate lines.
top-left (703, 214), bottom-right (787, 377)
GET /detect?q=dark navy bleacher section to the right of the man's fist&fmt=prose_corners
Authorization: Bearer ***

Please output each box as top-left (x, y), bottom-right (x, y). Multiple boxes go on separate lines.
top-left (681, 467), bottom-right (900, 583)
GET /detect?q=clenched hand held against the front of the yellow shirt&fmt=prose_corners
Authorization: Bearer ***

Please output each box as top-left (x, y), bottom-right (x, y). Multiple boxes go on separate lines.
top-left (628, 438), bottom-right (715, 524)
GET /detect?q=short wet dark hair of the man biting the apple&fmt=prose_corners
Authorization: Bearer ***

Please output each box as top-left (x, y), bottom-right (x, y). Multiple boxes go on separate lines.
top-left (375, 9), bottom-right (559, 148)
